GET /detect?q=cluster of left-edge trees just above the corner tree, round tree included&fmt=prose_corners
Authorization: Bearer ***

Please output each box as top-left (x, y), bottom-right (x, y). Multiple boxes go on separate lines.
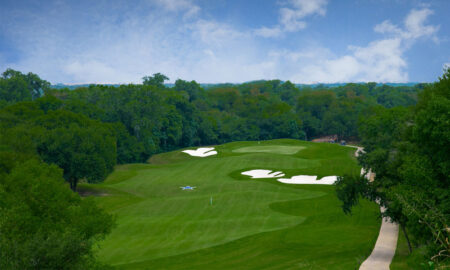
top-left (0, 102), bottom-right (117, 190)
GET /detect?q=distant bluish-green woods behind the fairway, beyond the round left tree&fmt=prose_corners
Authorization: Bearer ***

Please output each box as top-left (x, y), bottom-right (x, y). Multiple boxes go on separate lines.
top-left (37, 73), bottom-right (419, 163)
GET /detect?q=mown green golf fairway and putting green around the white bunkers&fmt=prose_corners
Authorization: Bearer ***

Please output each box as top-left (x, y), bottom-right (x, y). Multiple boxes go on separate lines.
top-left (83, 140), bottom-right (380, 269)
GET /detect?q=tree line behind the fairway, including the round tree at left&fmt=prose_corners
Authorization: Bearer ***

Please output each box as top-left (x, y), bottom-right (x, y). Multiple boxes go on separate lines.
top-left (0, 69), bottom-right (424, 190)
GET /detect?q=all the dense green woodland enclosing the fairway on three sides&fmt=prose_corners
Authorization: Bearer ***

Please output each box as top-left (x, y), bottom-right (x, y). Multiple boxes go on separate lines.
top-left (0, 69), bottom-right (450, 269)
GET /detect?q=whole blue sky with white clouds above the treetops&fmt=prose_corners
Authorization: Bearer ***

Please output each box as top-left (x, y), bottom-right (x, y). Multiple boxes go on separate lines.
top-left (0, 0), bottom-right (450, 84)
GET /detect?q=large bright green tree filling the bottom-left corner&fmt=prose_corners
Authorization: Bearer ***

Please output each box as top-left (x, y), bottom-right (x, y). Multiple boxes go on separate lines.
top-left (0, 159), bottom-right (114, 270)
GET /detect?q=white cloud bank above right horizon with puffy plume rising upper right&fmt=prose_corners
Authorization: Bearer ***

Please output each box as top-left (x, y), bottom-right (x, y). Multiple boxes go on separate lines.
top-left (276, 8), bottom-right (439, 83)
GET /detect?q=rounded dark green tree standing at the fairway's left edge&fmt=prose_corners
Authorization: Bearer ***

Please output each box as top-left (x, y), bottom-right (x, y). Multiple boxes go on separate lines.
top-left (37, 110), bottom-right (117, 191)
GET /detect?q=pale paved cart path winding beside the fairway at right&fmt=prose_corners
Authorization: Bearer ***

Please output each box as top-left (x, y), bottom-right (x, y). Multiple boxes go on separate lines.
top-left (349, 145), bottom-right (398, 270)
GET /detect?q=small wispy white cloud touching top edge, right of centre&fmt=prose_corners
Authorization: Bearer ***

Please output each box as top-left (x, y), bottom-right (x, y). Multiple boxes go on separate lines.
top-left (255, 0), bottom-right (328, 37)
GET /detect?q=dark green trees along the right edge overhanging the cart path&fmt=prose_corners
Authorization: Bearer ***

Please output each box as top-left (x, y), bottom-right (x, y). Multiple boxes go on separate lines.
top-left (337, 70), bottom-right (450, 268)
